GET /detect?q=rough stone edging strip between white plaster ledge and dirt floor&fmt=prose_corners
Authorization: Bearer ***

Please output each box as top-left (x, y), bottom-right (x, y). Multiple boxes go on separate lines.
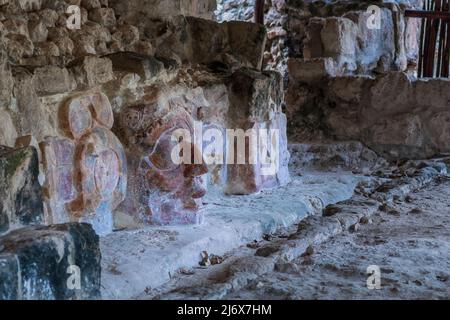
top-left (139, 158), bottom-right (448, 300)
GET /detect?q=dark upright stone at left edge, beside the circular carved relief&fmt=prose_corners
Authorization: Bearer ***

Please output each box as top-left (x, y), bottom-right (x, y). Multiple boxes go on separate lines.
top-left (0, 147), bottom-right (44, 233)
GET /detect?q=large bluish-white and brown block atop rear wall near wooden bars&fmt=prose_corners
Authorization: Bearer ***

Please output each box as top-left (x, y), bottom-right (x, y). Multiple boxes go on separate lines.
top-left (298, 1), bottom-right (408, 74)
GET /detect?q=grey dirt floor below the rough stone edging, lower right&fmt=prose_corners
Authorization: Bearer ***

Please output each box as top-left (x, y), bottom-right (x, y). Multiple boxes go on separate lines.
top-left (225, 179), bottom-right (450, 299)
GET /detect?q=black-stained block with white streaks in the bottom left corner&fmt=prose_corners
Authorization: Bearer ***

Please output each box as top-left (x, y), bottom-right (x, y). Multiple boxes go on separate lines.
top-left (0, 223), bottom-right (101, 300)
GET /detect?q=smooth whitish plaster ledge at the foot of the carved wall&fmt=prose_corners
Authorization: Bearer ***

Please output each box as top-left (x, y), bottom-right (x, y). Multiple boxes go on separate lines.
top-left (101, 172), bottom-right (364, 299)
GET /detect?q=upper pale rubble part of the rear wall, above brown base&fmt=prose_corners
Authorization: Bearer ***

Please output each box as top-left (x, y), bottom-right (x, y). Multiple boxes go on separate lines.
top-left (216, 0), bottom-right (422, 78)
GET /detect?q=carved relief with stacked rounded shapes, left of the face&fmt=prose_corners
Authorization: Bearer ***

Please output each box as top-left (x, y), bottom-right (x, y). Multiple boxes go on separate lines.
top-left (41, 92), bottom-right (127, 234)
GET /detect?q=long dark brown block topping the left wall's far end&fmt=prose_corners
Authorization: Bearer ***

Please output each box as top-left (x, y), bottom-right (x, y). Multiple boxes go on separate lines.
top-left (145, 16), bottom-right (266, 71)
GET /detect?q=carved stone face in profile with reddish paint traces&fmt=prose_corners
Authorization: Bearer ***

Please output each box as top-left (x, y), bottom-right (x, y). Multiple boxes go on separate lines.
top-left (116, 106), bottom-right (208, 225)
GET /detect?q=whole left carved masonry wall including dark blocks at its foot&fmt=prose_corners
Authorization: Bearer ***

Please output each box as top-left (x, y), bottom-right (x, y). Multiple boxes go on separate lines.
top-left (0, 0), bottom-right (289, 299)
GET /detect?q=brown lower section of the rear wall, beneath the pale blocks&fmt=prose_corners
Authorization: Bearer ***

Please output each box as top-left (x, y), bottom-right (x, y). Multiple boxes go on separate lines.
top-left (288, 72), bottom-right (450, 159)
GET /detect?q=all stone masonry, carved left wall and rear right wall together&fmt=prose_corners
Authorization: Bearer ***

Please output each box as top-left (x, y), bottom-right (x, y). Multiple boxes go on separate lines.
top-left (0, 0), bottom-right (450, 299)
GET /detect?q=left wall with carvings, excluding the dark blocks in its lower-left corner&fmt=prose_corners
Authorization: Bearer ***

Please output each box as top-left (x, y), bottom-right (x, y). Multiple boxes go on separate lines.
top-left (0, 0), bottom-right (289, 234)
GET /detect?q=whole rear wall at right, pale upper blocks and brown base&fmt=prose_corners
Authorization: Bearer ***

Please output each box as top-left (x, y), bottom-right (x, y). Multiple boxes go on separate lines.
top-left (216, 0), bottom-right (450, 159)
